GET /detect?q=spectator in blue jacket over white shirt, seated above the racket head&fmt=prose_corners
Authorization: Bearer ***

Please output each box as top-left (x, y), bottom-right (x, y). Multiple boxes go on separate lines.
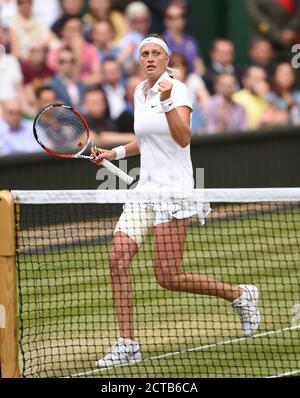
top-left (49, 48), bottom-right (85, 107)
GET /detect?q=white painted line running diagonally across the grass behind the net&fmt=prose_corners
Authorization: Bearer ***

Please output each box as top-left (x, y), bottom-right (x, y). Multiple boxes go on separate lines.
top-left (67, 325), bottom-right (300, 378)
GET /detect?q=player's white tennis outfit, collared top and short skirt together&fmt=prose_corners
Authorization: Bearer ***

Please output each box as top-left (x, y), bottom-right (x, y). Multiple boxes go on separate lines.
top-left (115, 72), bottom-right (210, 245)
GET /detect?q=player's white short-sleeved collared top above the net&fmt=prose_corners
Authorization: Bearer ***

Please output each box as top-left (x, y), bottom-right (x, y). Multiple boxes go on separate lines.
top-left (134, 72), bottom-right (194, 191)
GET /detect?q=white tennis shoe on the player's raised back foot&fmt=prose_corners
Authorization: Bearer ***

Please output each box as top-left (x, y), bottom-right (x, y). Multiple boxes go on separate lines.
top-left (232, 285), bottom-right (260, 337)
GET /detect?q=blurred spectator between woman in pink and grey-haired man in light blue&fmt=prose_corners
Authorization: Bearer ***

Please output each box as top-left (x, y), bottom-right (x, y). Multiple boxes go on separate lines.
top-left (92, 21), bottom-right (119, 62)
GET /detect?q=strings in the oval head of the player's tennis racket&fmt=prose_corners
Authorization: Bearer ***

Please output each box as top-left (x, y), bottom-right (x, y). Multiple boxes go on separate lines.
top-left (35, 106), bottom-right (89, 157)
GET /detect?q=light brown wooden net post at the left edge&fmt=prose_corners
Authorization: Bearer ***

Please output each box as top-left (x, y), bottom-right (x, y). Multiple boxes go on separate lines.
top-left (0, 191), bottom-right (20, 378)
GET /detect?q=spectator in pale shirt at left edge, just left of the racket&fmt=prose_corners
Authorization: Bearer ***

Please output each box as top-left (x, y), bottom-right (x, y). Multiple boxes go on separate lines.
top-left (0, 100), bottom-right (41, 156)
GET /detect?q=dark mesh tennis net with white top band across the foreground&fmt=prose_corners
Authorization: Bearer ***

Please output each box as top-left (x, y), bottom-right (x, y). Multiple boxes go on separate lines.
top-left (7, 189), bottom-right (300, 378)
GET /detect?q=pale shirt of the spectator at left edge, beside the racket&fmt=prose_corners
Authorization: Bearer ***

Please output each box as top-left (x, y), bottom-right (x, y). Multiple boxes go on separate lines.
top-left (0, 118), bottom-right (42, 156)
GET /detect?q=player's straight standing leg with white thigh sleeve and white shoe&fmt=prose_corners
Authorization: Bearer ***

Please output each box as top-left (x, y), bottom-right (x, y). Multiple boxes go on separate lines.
top-left (96, 208), bottom-right (153, 367)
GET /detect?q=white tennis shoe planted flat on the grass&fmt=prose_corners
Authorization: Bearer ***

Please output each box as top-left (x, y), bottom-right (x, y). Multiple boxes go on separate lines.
top-left (96, 337), bottom-right (142, 368)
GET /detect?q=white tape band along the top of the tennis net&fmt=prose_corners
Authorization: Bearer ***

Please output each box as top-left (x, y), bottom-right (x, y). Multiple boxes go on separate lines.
top-left (12, 188), bottom-right (300, 204)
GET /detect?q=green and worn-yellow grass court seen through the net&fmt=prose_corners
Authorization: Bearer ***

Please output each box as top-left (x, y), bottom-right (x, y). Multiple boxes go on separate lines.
top-left (18, 211), bottom-right (300, 378)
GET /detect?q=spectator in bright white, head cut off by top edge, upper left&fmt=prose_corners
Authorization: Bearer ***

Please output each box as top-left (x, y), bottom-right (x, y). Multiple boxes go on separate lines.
top-left (32, 0), bottom-right (62, 29)
